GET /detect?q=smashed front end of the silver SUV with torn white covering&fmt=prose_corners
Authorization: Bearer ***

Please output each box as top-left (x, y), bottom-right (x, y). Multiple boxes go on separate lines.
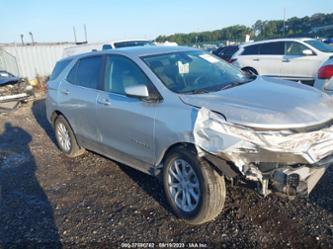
top-left (194, 108), bottom-right (333, 197)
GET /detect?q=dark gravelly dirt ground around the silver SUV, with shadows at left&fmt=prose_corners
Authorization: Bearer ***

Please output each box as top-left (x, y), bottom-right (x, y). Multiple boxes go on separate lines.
top-left (0, 100), bottom-right (333, 248)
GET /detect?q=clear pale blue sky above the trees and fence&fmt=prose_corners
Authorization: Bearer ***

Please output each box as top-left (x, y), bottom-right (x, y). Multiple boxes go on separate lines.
top-left (0, 0), bottom-right (333, 43)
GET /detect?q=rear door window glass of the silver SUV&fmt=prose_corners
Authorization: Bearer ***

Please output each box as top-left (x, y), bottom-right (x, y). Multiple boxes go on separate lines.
top-left (67, 56), bottom-right (102, 89)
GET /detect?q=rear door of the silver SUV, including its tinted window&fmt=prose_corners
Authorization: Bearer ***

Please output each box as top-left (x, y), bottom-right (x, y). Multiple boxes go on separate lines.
top-left (59, 55), bottom-right (102, 150)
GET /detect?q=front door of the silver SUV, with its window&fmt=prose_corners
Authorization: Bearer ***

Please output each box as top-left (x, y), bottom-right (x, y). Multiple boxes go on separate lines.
top-left (95, 55), bottom-right (158, 171)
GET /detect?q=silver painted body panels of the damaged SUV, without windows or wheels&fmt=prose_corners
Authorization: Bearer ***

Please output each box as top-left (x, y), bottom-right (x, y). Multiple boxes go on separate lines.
top-left (46, 47), bottom-right (333, 179)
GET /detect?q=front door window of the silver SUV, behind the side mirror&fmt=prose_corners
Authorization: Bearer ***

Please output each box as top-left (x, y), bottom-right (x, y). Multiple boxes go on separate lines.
top-left (104, 55), bottom-right (150, 95)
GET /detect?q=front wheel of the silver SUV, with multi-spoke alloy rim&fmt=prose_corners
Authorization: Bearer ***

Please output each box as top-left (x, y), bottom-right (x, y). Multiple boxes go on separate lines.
top-left (163, 147), bottom-right (226, 225)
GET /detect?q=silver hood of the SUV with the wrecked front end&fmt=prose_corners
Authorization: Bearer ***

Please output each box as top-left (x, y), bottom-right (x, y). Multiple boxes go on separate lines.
top-left (180, 77), bottom-right (333, 129)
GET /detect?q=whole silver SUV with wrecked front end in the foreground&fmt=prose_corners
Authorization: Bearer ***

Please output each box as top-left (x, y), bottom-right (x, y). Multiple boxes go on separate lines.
top-left (46, 47), bottom-right (333, 224)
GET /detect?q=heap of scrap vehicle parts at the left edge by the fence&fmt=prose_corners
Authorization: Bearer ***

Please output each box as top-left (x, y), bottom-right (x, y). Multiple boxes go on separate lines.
top-left (0, 71), bottom-right (34, 113)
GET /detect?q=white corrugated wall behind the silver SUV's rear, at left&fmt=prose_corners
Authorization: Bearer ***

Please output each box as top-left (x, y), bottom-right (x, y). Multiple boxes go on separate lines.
top-left (0, 43), bottom-right (73, 79)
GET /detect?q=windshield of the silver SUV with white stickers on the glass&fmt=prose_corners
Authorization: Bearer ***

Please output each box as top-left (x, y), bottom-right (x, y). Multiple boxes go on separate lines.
top-left (143, 51), bottom-right (254, 93)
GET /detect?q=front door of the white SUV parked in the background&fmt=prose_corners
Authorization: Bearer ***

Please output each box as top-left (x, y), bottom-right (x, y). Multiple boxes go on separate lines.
top-left (281, 41), bottom-right (322, 80)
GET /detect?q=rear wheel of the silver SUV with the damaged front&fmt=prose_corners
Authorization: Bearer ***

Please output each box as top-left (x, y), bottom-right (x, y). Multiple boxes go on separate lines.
top-left (54, 115), bottom-right (85, 157)
